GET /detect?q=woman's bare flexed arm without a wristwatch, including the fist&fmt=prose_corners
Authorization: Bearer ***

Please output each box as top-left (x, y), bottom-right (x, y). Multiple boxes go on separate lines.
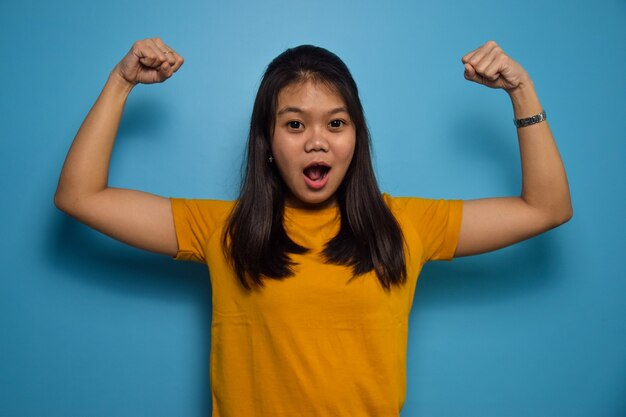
top-left (54, 38), bottom-right (183, 256)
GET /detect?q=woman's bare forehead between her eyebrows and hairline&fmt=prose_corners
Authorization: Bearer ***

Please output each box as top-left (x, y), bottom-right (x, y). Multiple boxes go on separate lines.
top-left (276, 80), bottom-right (346, 112)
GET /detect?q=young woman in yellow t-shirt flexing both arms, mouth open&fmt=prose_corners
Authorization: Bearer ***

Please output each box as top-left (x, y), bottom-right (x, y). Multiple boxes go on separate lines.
top-left (55, 39), bottom-right (572, 417)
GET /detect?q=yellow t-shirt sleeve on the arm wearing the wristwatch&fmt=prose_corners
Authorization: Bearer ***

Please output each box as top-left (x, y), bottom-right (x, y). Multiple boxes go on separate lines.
top-left (394, 194), bottom-right (463, 262)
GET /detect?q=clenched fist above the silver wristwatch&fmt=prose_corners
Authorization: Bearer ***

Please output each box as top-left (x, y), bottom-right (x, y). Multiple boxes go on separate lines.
top-left (461, 41), bottom-right (530, 94)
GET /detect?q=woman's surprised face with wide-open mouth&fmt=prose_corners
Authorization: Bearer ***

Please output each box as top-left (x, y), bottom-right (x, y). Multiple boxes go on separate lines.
top-left (271, 80), bottom-right (356, 208)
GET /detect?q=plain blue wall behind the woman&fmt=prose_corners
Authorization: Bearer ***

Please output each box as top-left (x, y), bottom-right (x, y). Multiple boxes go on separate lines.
top-left (0, 0), bottom-right (626, 417)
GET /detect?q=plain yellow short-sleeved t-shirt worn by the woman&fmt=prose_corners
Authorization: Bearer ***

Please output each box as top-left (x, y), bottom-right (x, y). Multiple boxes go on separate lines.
top-left (171, 194), bottom-right (462, 417)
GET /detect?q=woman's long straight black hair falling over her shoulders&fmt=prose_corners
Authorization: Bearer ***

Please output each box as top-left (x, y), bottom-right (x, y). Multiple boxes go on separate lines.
top-left (223, 45), bottom-right (406, 289)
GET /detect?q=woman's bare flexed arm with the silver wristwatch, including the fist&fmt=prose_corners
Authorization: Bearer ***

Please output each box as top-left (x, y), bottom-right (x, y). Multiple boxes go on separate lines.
top-left (454, 41), bottom-right (573, 257)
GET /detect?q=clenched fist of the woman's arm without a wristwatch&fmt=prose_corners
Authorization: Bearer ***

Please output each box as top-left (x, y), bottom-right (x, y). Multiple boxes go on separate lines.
top-left (113, 38), bottom-right (184, 86)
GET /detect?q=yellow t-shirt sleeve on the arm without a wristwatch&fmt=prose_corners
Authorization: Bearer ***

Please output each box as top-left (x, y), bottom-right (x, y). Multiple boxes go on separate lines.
top-left (170, 197), bottom-right (231, 264)
